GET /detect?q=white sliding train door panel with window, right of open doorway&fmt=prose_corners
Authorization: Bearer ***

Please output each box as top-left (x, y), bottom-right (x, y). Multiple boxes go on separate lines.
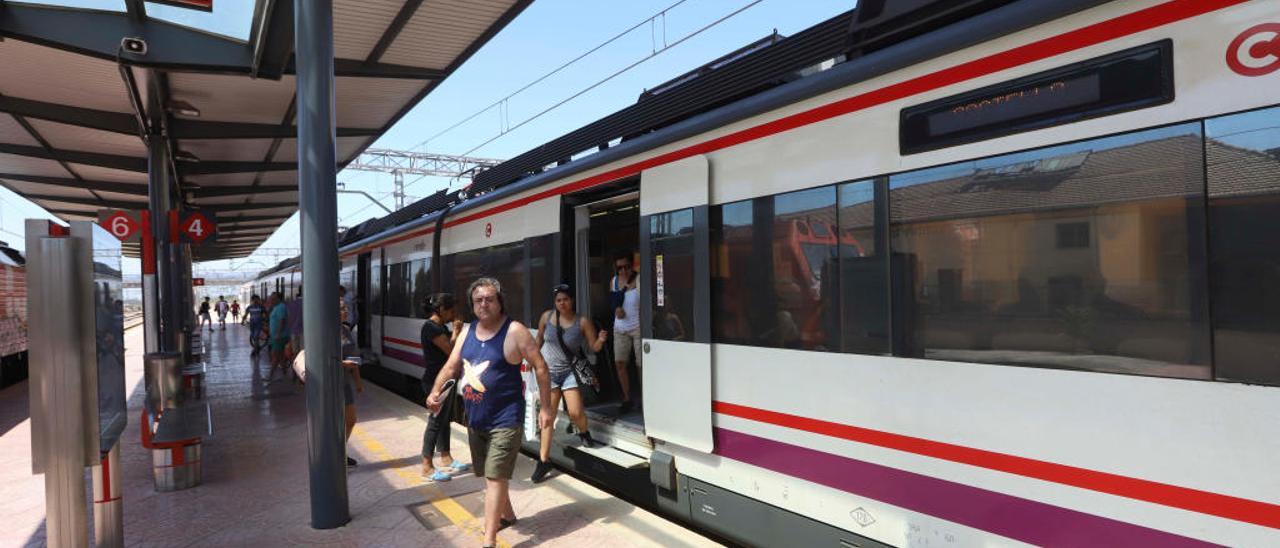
top-left (640, 156), bottom-right (713, 452)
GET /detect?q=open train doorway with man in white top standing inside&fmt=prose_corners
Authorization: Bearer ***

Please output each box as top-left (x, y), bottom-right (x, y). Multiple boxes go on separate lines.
top-left (570, 183), bottom-right (650, 458)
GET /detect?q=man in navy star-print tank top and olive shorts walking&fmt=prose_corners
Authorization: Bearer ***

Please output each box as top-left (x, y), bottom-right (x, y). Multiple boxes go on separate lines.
top-left (426, 278), bottom-right (552, 547)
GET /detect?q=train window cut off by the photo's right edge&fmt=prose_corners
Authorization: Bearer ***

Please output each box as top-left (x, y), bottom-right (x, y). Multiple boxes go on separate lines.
top-left (1204, 103), bottom-right (1280, 384)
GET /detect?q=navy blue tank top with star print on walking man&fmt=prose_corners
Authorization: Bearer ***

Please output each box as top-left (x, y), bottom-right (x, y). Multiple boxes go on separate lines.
top-left (460, 318), bottom-right (525, 430)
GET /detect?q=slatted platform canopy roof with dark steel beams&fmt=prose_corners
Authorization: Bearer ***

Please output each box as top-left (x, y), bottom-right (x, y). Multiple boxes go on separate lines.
top-left (0, 0), bottom-right (531, 260)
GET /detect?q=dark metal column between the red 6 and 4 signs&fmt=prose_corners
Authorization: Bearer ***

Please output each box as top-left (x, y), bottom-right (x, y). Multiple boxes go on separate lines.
top-left (143, 133), bottom-right (178, 351)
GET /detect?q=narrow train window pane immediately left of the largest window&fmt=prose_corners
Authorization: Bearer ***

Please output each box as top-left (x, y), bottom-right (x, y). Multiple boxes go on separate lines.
top-left (824, 181), bottom-right (890, 355)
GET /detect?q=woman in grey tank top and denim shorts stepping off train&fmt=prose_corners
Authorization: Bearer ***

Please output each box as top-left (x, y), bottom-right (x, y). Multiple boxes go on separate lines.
top-left (530, 283), bottom-right (609, 483)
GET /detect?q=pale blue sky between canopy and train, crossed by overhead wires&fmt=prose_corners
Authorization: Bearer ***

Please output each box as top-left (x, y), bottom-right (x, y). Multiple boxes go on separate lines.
top-left (0, 0), bottom-right (855, 273)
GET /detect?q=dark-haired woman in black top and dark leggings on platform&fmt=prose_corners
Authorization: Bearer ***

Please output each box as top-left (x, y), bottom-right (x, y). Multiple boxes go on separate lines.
top-left (421, 293), bottom-right (471, 481)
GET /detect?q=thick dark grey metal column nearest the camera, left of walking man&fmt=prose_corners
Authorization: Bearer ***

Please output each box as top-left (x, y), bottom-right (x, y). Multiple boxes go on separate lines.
top-left (293, 0), bottom-right (351, 529)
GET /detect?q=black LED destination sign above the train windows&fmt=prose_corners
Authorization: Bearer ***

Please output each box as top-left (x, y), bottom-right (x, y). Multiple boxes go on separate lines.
top-left (900, 41), bottom-right (1174, 154)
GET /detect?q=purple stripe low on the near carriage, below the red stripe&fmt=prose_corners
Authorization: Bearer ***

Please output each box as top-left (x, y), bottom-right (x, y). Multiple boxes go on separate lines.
top-left (716, 428), bottom-right (1215, 547)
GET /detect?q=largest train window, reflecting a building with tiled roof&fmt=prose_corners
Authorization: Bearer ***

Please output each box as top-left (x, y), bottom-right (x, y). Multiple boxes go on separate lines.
top-left (888, 123), bottom-right (1210, 379)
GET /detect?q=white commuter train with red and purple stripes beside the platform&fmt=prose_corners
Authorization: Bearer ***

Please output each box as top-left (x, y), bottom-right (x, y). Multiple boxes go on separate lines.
top-left (252, 0), bottom-right (1280, 547)
